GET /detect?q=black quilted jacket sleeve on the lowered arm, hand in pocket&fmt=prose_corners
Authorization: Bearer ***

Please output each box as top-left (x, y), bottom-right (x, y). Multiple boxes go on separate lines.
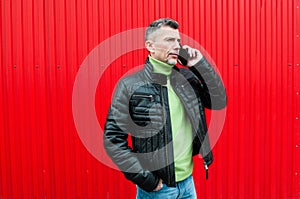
top-left (103, 81), bottom-right (159, 191)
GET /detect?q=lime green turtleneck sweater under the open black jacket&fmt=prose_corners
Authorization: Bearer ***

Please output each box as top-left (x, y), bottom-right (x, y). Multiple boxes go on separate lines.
top-left (149, 56), bottom-right (194, 182)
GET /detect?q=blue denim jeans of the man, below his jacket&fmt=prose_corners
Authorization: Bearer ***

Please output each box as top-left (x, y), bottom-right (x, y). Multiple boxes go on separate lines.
top-left (136, 175), bottom-right (197, 199)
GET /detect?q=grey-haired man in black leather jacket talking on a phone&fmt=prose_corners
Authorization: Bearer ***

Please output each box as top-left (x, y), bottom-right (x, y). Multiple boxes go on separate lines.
top-left (104, 18), bottom-right (226, 198)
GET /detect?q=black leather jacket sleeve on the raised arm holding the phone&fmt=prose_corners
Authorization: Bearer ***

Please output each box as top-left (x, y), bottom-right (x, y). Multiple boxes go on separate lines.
top-left (190, 57), bottom-right (227, 110)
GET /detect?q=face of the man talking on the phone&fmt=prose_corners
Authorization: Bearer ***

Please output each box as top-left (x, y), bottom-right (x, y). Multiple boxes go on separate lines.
top-left (146, 26), bottom-right (180, 65)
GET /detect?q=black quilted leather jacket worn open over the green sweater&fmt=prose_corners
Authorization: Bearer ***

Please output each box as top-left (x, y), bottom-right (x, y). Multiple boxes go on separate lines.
top-left (104, 58), bottom-right (226, 191)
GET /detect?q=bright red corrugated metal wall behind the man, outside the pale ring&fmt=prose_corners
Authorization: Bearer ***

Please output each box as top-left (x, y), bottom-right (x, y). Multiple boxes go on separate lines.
top-left (0, 0), bottom-right (300, 199)
